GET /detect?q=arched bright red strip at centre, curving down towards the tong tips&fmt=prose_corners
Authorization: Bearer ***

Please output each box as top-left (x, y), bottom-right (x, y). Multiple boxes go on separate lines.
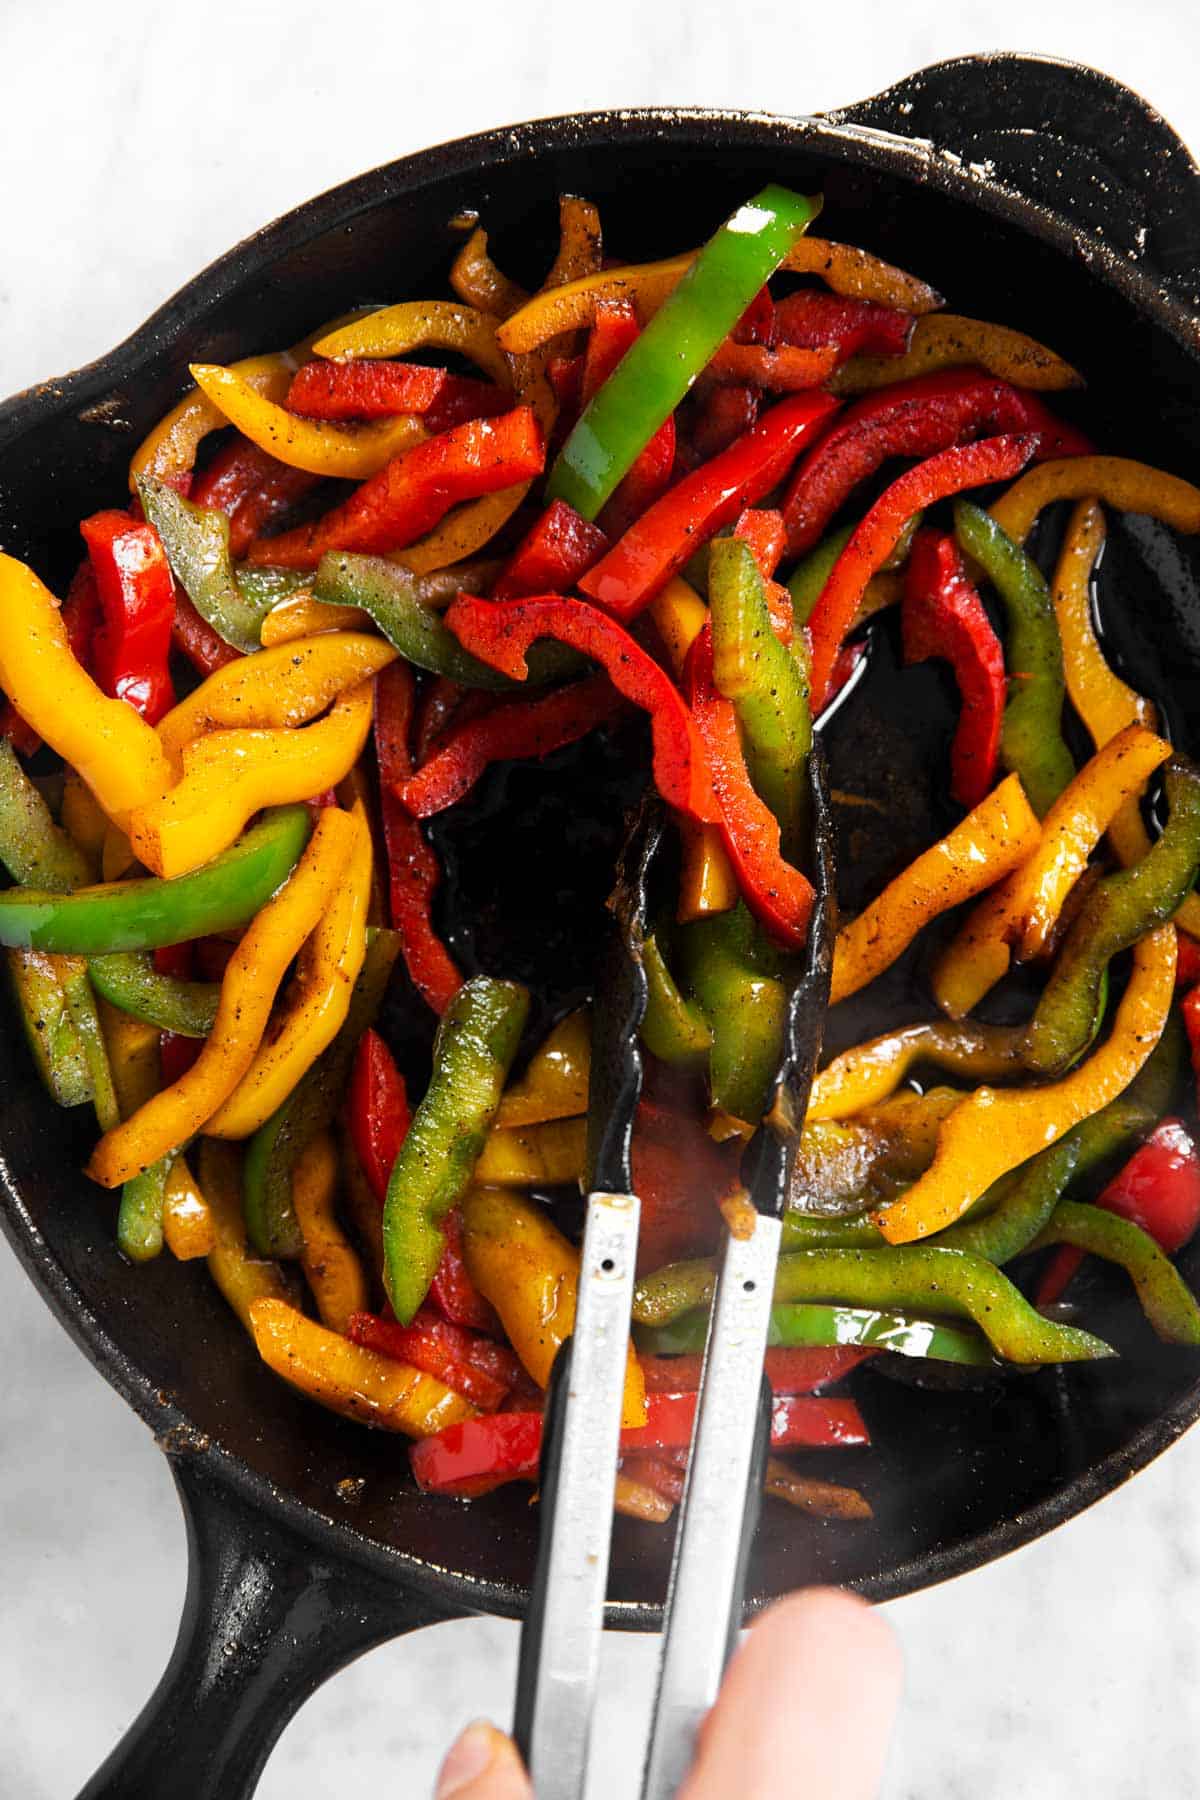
top-left (446, 594), bottom-right (718, 823)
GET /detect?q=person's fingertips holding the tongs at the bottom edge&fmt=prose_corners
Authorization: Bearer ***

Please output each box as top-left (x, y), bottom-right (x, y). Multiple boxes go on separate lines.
top-left (435, 1588), bottom-right (901, 1800)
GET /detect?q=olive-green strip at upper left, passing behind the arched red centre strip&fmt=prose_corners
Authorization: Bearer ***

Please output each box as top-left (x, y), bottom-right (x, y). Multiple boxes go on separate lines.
top-left (313, 551), bottom-right (587, 693)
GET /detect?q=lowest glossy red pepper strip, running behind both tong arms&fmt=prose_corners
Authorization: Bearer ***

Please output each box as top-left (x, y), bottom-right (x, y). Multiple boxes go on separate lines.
top-left (408, 1393), bottom-right (871, 1498)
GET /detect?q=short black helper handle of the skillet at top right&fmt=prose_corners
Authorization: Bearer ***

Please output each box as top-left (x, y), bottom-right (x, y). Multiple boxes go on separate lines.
top-left (829, 52), bottom-right (1200, 310)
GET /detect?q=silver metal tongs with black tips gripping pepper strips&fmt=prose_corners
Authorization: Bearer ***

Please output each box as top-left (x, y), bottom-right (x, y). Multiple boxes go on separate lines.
top-left (515, 749), bottom-right (835, 1800)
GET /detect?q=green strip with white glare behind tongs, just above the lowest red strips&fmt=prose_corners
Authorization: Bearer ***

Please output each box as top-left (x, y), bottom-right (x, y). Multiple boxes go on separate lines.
top-left (637, 1305), bottom-right (995, 1368)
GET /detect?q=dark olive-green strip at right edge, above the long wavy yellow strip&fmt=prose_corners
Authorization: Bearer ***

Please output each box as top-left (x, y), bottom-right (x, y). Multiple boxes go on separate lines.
top-left (1024, 756), bottom-right (1200, 1075)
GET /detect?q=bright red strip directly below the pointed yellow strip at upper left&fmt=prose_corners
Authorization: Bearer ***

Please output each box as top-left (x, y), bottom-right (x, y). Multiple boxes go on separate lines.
top-left (246, 407), bottom-right (545, 569)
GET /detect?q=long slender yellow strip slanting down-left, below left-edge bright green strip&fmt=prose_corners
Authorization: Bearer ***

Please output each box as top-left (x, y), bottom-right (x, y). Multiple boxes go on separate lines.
top-left (88, 808), bottom-right (356, 1188)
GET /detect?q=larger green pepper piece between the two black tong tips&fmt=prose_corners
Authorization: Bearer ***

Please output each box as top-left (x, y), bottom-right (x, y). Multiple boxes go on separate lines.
top-left (678, 900), bottom-right (788, 1123)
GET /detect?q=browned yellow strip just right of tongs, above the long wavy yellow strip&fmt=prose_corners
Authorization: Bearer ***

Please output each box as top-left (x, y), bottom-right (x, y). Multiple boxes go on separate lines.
top-left (806, 1021), bottom-right (1024, 1123)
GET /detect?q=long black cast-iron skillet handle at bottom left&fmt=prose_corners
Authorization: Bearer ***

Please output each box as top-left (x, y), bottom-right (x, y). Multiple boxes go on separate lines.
top-left (79, 1456), bottom-right (462, 1800)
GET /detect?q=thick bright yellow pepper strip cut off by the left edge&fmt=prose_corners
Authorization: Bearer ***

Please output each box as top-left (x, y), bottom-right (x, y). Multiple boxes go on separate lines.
top-left (0, 553), bottom-right (171, 821)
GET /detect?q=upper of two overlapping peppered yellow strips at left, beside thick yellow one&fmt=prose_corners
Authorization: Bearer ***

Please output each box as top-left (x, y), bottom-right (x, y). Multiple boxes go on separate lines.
top-left (158, 630), bottom-right (396, 763)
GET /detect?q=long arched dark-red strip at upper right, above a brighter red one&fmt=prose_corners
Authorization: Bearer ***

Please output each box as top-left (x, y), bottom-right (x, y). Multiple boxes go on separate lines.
top-left (783, 369), bottom-right (1092, 556)
